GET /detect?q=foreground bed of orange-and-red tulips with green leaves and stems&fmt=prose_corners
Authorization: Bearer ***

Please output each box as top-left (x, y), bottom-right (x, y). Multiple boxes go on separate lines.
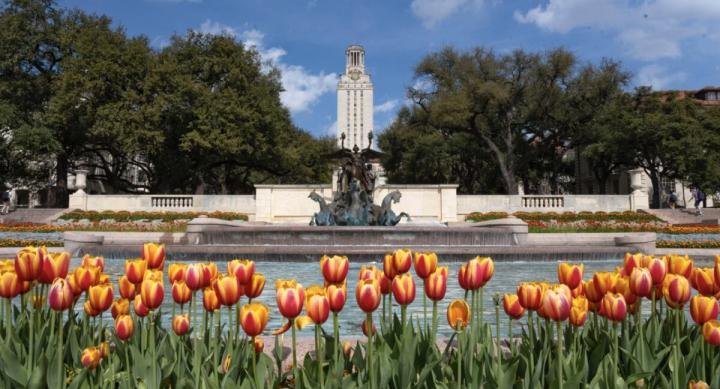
top-left (0, 244), bottom-right (720, 388)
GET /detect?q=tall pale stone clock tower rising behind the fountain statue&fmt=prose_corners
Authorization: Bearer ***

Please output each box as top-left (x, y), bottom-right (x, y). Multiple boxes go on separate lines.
top-left (336, 45), bottom-right (373, 149)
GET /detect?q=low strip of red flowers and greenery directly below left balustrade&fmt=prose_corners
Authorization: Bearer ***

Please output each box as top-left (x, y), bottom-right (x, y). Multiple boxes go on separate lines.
top-left (60, 209), bottom-right (248, 223)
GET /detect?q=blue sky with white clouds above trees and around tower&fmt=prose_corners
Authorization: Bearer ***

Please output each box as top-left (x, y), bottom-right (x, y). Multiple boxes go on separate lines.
top-left (59, 0), bottom-right (720, 135)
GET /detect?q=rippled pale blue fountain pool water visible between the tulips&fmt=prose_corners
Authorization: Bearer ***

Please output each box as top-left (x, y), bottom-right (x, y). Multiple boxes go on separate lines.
top-left (72, 257), bottom-right (709, 336)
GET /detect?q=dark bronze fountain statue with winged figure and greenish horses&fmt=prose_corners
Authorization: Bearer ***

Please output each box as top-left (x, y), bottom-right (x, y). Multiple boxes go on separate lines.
top-left (308, 132), bottom-right (410, 226)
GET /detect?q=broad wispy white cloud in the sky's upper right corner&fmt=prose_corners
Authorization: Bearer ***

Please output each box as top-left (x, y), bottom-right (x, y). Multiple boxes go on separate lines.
top-left (515, 0), bottom-right (720, 61)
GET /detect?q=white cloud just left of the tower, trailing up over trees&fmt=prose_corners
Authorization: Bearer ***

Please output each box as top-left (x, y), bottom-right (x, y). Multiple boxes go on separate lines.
top-left (193, 20), bottom-right (338, 113)
